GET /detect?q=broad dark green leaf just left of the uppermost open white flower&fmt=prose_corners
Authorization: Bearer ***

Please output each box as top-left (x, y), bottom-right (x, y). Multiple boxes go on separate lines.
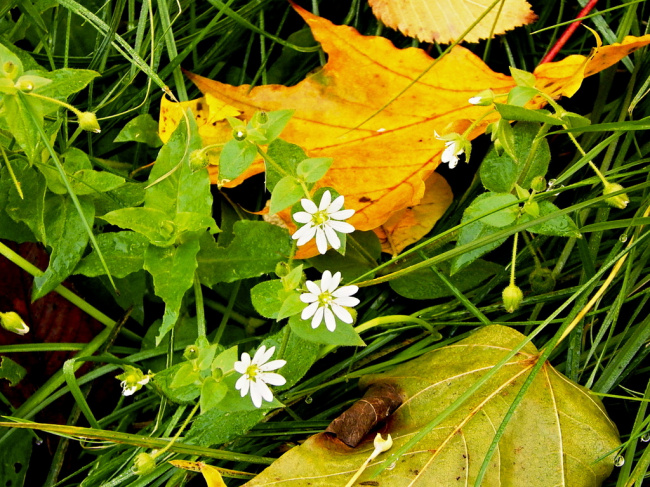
top-left (198, 220), bottom-right (291, 286)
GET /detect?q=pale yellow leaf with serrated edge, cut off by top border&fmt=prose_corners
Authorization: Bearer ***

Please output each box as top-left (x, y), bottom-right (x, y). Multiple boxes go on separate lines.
top-left (368, 0), bottom-right (537, 44)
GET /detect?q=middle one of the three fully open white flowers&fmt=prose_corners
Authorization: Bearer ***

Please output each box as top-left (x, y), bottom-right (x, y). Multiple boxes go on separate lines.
top-left (300, 271), bottom-right (359, 331)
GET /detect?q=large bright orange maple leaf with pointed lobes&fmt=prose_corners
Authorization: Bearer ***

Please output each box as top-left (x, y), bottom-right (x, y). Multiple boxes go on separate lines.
top-left (161, 7), bottom-right (650, 258)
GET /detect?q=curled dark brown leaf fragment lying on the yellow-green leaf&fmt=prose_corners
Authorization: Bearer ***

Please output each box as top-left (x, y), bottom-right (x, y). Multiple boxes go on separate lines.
top-left (325, 384), bottom-right (402, 448)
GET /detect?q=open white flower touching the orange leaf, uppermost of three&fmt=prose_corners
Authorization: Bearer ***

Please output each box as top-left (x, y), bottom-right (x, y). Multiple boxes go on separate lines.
top-left (292, 190), bottom-right (354, 254)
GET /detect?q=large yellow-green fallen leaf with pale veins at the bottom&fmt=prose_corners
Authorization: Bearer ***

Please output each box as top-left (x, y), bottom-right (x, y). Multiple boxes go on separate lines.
top-left (245, 325), bottom-right (620, 487)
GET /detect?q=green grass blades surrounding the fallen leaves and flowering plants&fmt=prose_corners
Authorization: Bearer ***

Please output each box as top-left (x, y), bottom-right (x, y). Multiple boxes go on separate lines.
top-left (0, 0), bottom-right (650, 487)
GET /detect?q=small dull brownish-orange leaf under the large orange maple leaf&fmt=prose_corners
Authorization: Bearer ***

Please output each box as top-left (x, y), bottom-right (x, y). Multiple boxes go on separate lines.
top-left (375, 172), bottom-right (454, 256)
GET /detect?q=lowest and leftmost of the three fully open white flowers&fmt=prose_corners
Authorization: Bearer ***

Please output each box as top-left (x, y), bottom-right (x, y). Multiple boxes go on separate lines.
top-left (235, 345), bottom-right (287, 408)
